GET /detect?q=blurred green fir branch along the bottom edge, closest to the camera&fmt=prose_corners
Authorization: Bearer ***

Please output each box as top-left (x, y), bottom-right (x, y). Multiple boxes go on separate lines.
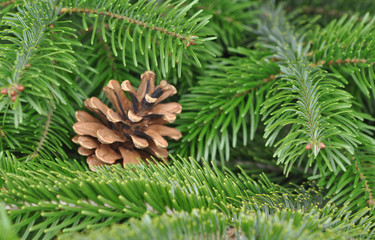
top-left (61, 209), bottom-right (366, 240)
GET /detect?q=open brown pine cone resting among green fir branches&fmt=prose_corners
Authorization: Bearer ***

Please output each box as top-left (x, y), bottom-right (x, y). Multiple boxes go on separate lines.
top-left (73, 71), bottom-right (181, 171)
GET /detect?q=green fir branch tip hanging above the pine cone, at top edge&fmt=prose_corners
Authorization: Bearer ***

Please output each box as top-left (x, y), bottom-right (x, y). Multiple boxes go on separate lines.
top-left (60, 0), bottom-right (212, 77)
